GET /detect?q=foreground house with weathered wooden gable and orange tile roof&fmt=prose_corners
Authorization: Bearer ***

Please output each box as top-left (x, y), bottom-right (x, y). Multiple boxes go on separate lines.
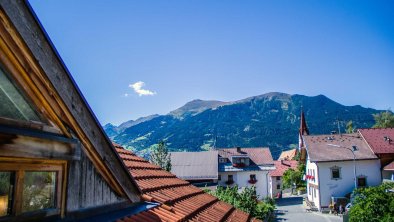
top-left (0, 0), bottom-right (253, 221)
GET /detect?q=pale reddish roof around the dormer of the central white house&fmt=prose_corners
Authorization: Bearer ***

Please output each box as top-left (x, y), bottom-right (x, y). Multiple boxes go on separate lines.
top-left (218, 147), bottom-right (274, 165)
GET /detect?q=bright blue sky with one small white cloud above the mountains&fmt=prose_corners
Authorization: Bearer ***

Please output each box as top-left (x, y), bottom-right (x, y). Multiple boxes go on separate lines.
top-left (30, 0), bottom-right (394, 124)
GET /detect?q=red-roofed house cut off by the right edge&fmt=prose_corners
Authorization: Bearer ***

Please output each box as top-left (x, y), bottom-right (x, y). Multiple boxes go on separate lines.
top-left (358, 128), bottom-right (394, 181)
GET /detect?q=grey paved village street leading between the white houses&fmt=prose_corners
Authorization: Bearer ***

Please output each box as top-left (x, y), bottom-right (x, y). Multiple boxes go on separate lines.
top-left (275, 196), bottom-right (342, 222)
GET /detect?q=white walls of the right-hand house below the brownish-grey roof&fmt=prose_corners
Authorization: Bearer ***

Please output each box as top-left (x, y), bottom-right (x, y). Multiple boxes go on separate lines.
top-left (307, 160), bottom-right (381, 210)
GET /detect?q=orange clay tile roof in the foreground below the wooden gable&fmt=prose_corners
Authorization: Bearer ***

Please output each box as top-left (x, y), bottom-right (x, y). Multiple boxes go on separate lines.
top-left (114, 144), bottom-right (254, 222)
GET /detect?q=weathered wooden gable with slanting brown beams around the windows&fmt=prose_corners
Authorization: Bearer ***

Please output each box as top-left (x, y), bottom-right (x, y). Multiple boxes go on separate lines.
top-left (0, 1), bottom-right (140, 220)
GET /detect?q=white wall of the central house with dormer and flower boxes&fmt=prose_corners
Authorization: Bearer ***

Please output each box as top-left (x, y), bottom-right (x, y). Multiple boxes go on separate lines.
top-left (218, 171), bottom-right (269, 199)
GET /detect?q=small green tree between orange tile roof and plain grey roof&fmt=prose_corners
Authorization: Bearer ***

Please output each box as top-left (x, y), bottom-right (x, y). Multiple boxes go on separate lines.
top-left (149, 141), bottom-right (172, 171)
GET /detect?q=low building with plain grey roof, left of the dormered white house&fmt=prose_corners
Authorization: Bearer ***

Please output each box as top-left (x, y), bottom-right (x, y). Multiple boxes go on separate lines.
top-left (170, 151), bottom-right (218, 187)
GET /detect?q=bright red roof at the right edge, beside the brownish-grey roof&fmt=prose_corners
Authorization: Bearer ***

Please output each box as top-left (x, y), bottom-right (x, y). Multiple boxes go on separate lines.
top-left (359, 128), bottom-right (394, 154)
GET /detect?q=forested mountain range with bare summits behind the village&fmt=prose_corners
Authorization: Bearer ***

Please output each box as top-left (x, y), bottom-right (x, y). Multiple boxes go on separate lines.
top-left (104, 92), bottom-right (381, 158)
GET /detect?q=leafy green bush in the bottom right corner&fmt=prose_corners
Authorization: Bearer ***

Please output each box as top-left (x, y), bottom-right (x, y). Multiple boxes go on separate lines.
top-left (349, 183), bottom-right (394, 222)
